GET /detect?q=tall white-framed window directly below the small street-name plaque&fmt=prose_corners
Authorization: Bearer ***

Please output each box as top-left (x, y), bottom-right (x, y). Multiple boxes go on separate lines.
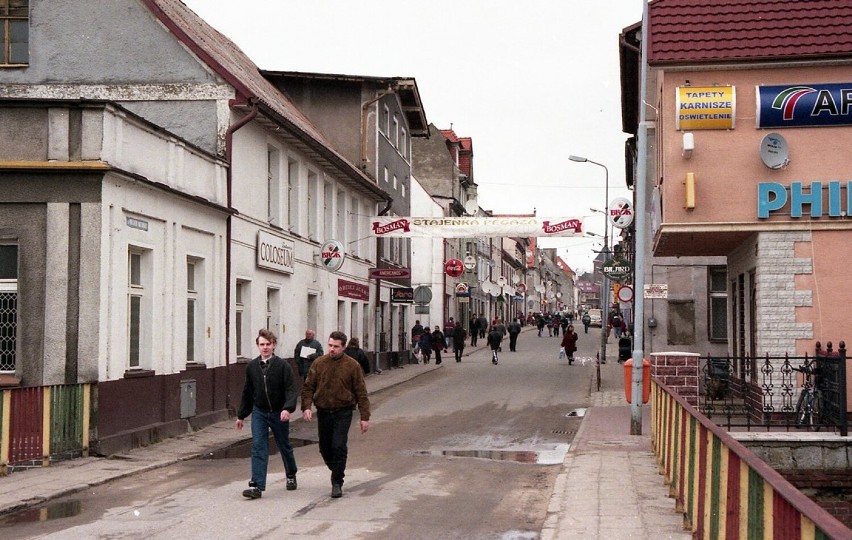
top-left (127, 246), bottom-right (152, 369)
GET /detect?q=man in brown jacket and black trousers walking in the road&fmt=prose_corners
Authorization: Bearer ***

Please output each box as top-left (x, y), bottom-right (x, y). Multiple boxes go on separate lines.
top-left (302, 331), bottom-right (370, 499)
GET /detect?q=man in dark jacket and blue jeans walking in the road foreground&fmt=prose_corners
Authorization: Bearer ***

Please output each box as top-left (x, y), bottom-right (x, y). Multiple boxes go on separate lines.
top-left (237, 329), bottom-right (297, 499)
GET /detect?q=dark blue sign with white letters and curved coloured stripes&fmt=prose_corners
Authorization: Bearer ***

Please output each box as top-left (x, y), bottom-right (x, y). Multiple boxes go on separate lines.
top-left (756, 82), bottom-right (852, 128)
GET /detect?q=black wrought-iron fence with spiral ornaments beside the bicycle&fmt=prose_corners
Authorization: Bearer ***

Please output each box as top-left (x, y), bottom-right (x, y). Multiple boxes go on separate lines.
top-left (699, 342), bottom-right (848, 436)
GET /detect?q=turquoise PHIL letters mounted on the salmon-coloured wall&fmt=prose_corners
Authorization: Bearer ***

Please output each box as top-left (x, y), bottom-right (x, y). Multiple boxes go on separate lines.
top-left (757, 181), bottom-right (852, 219)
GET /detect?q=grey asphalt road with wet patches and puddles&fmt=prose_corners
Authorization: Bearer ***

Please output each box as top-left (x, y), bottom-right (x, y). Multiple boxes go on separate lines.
top-left (0, 326), bottom-right (613, 539)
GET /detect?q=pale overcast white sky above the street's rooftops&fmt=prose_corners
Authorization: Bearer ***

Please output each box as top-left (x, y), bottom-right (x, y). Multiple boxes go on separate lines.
top-left (184, 0), bottom-right (642, 270)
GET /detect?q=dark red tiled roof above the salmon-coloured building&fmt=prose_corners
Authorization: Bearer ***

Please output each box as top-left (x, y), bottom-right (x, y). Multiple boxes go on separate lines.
top-left (648, 0), bottom-right (852, 65)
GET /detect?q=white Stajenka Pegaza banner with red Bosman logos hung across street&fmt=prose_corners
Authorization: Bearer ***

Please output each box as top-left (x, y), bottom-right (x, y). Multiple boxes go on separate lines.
top-left (370, 216), bottom-right (583, 238)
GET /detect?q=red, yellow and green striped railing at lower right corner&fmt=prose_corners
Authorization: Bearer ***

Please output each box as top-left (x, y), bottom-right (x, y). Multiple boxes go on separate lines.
top-left (651, 380), bottom-right (852, 540)
